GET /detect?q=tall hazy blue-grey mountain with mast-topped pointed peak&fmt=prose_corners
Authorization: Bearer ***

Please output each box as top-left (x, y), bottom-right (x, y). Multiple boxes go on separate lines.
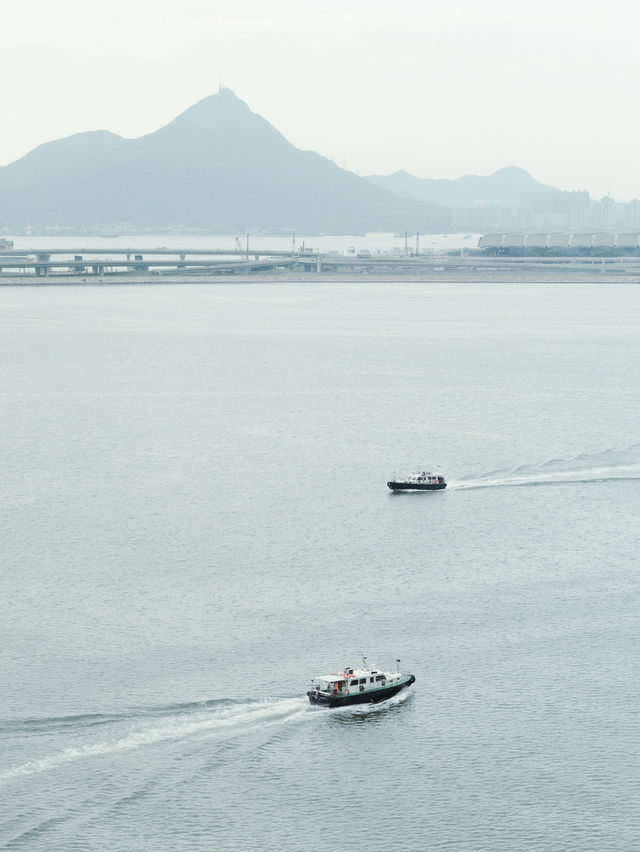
top-left (0, 89), bottom-right (450, 233)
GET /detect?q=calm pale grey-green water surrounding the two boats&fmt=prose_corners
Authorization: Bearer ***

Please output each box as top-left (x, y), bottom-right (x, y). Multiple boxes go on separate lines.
top-left (0, 282), bottom-right (640, 852)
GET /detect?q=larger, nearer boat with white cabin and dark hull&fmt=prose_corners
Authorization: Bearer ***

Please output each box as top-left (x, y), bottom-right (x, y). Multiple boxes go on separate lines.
top-left (307, 657), bottom-right (415, 707)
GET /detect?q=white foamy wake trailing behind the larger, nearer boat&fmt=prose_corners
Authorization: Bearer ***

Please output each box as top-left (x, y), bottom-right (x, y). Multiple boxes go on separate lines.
top-left (0, 696), bottom-right (314, 782)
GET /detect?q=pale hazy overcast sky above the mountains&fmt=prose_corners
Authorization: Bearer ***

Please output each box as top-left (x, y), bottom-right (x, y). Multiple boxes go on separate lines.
top-left (5, 0), bottom-right (640, 200)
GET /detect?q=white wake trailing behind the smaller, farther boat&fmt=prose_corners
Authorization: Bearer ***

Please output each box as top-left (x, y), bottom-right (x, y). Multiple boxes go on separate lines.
top-left (449, 444), bottom-right (640, 491)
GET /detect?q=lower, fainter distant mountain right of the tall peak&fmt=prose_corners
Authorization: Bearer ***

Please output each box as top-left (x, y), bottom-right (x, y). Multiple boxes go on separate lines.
top-left (367, 166), bottom-right (556, 207)
